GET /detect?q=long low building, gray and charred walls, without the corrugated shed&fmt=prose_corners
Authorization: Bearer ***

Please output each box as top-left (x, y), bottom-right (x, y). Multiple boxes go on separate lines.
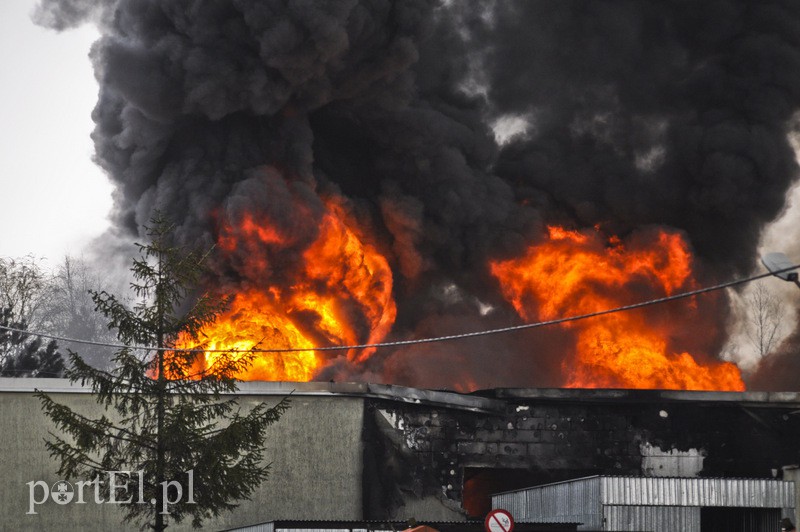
top-left (0, 379), bottom-right (800, 530)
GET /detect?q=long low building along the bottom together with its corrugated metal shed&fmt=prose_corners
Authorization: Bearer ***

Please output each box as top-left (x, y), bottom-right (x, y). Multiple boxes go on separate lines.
top-left (9, 379), bottom-right (800, 532)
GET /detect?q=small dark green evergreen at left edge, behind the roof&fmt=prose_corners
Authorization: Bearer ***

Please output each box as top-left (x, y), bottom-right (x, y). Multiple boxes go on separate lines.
top-left (0, 307), bottom-right (64, 377)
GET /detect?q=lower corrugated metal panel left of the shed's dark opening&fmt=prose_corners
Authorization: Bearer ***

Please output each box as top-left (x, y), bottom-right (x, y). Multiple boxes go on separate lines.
top-left (603, 506), bottom-right (700, 532)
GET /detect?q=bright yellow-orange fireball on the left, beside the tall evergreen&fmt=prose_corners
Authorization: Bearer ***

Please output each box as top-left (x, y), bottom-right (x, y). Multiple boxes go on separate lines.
top-left (180, 193), bottom-right (397, 381)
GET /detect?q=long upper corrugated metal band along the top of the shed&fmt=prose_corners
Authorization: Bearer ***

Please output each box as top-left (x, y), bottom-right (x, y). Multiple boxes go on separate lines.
top-left (600, 477), bottom-right (795, 508)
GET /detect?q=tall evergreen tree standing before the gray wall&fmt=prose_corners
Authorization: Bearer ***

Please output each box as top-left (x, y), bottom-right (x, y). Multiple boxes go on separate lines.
top-left (38, 217), bottom-right (288, 531)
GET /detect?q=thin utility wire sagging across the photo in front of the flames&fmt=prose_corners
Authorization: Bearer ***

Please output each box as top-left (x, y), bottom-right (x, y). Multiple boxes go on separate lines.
top-left (0, 264), bottom-right (800, 353)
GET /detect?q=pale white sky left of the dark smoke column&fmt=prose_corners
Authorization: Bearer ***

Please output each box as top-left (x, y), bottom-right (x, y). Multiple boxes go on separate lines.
top-left (0, 0), bottom-right (112, 265)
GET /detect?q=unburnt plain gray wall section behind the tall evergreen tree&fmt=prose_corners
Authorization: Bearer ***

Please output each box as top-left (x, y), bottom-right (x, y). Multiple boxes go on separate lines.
top-left (0, 386), bottom-right (363, 531)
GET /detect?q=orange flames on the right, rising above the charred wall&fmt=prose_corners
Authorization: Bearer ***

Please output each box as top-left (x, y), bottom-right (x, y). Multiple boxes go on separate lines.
top-left (490, 227), bottom-right (745, 390)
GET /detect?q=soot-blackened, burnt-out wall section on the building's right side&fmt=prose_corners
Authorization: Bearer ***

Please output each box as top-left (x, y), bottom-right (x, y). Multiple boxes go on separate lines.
top-left (367, 389), bottom-right (800, 518)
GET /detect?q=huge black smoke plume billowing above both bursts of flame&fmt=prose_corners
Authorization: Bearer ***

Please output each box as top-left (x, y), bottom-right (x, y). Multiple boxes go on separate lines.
top-left (36, 0), bottom-right (800, 387)
